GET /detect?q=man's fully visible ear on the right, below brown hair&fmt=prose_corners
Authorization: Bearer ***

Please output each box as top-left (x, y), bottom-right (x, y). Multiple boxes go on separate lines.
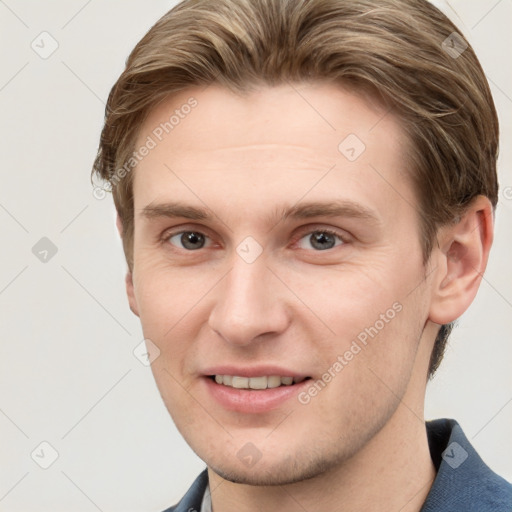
top-left (429, 196), bottom-right (494, 325)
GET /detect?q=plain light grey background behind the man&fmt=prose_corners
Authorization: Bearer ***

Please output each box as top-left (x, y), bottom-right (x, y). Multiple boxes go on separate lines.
top-left (0, 0), bottom-right (512, 512)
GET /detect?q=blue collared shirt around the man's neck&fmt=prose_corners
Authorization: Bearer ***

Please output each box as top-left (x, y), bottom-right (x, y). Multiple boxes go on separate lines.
top-left (164, 419), bottom-right (512, 512)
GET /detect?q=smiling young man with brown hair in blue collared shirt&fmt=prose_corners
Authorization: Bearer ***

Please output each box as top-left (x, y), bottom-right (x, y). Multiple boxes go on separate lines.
top-left (95, 0), bottom-right (512, 512)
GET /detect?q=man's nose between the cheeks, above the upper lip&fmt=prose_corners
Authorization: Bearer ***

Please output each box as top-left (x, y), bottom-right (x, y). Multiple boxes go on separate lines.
top-left (209, 255), bottom-right (289, 346)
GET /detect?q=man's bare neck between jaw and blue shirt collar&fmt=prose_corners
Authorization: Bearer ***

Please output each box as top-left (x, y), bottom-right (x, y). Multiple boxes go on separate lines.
top-left (208, 394), bottom-right (435, 512)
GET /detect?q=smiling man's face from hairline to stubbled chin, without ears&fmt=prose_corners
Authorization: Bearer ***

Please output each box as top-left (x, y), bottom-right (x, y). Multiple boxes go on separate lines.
top-left (129, 83), bottom-right (431, 484)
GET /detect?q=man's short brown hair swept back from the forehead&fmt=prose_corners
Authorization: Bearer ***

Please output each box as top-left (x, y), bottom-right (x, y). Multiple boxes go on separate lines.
top-left (93, 0), bottom-right (498, 376)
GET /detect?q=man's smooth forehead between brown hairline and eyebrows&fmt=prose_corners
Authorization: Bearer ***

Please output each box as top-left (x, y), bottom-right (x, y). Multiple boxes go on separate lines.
top-left (130, 83), bottom-right (414, 226)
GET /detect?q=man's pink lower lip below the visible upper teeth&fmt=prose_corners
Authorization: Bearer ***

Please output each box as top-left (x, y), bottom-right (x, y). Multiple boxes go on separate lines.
top-left (203, 377), bottom-right (309, 413)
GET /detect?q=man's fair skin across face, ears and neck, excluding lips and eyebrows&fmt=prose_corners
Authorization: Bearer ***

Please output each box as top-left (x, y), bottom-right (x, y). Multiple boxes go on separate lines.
top-left (118, 82), bottom-right (492, 512)
